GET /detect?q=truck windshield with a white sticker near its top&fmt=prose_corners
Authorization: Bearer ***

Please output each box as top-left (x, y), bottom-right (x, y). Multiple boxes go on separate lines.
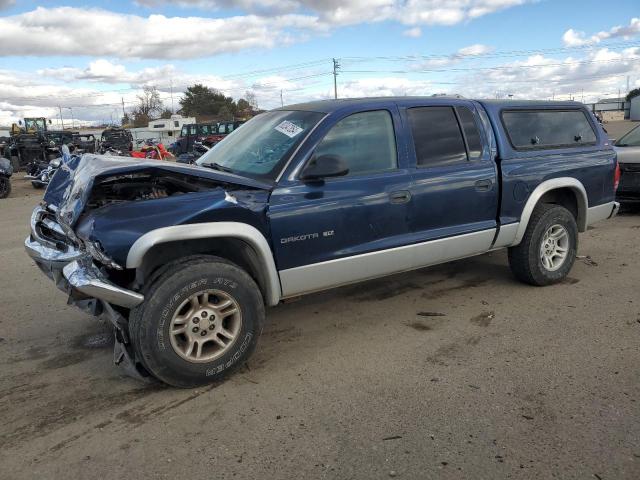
top-left (196, 110), bottom-right (324, 180)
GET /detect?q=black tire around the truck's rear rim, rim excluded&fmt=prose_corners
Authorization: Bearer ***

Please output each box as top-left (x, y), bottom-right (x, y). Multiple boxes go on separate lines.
top-left (509, 203), bottom-right (578, 286)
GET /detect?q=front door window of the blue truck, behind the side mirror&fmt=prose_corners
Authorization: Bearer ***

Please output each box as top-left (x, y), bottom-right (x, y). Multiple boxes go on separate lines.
top-left (315, 110), bottom-right (398, 175)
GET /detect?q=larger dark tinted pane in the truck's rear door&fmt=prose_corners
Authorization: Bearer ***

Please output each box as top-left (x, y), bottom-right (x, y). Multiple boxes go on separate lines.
top-left (408, 107), bottom-right (467, 167)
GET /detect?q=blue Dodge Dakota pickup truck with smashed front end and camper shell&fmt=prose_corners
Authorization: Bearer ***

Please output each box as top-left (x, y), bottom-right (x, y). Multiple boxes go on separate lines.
top-left (25, 97), bottom-right (619, 387)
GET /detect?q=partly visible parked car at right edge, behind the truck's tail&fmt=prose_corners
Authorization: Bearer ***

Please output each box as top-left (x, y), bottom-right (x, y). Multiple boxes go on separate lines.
top-left (615, 125), bottom-right (640, 204)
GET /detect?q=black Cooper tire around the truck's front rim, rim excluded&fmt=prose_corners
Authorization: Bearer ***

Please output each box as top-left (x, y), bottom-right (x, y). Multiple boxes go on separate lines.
top-left (129, 256), bottom-right (265, 388)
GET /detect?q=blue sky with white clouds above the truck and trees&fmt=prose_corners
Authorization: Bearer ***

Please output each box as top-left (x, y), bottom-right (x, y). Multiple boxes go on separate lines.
top-left (0, 0), bottom-right (640, 125)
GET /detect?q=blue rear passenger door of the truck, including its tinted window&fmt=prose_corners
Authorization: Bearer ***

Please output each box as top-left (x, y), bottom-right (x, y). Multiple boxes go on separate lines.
top-left (403, 102), bottom-right (499, 248)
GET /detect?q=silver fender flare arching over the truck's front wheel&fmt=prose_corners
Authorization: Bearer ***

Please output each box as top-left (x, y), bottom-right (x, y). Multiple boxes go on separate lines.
top-left (127, 222), bottom-right (282, 306)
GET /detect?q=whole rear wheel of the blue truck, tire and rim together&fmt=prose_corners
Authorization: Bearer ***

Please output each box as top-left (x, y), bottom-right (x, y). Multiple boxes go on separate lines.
top-left (509, 204), bottom-right (578, 286)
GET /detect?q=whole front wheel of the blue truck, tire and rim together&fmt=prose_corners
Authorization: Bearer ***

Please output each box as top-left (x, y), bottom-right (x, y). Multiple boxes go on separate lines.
top-left (129, 257), bottom-right (265, 388)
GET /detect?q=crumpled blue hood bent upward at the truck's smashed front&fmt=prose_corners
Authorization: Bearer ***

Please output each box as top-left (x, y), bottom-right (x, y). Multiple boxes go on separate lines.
top-left (44, 154), bottom-right (273, 233)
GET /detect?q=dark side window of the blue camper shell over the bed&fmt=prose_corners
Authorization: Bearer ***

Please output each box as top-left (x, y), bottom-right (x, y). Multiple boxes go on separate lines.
top-left (502, 110), bottom-right (596, 149)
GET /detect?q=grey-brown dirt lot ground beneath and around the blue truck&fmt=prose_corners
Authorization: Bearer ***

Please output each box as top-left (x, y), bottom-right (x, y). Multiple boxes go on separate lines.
top-left (0, 179), bottom-right (640, 480)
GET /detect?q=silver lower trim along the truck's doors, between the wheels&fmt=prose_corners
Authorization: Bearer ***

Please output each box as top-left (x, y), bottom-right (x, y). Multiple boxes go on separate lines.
top-left (279, 228), bottom-right (496, 298)
